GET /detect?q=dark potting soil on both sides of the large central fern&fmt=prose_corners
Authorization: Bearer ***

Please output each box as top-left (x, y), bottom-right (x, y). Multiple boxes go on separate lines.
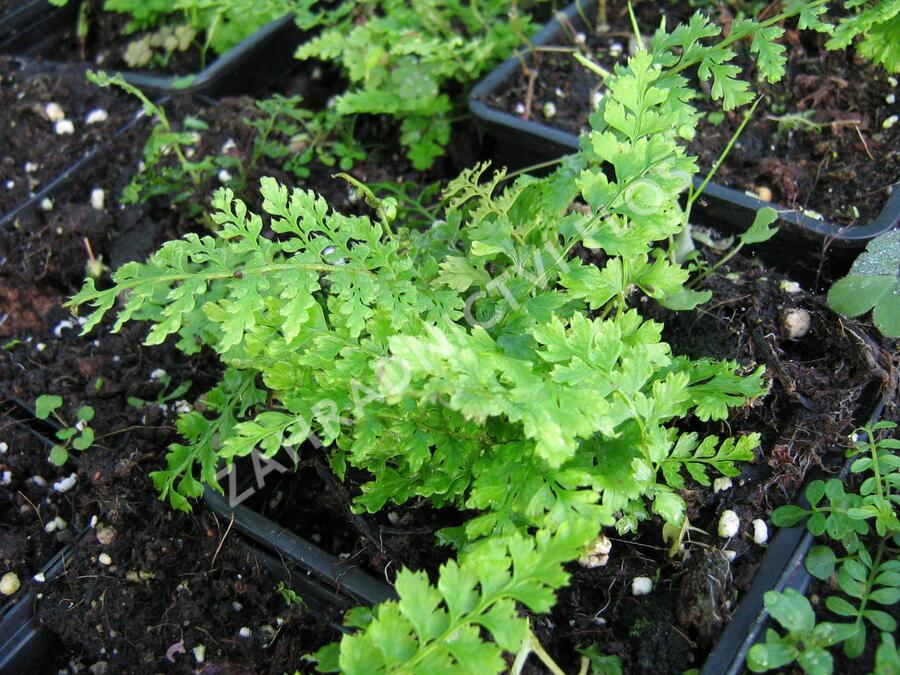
top-left (227, 243), bottom-right (897, 673)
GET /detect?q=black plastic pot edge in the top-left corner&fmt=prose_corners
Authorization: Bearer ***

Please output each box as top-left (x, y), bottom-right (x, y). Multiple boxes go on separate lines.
top-left (0, 0), bottom-right (302, 96)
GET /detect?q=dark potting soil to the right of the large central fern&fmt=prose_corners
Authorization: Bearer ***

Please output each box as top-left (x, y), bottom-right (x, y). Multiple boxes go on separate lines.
top-left (533, 246), bottom-right (897, 673)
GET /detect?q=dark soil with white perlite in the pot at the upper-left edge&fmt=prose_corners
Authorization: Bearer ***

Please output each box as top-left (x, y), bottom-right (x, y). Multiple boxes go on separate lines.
top-left (0, 57), bottom-right (138, 214)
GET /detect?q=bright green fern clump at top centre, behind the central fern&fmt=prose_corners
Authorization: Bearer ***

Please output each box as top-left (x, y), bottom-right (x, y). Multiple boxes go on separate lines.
top-left (297, 0), bottom-right (533, 169)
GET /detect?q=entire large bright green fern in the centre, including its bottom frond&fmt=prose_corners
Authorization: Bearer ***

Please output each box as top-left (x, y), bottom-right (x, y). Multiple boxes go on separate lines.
top-left (65, 2), bottom-right (819, 672)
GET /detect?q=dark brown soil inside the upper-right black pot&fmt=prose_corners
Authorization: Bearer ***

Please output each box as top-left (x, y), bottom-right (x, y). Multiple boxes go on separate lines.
top-left (488, 3), bottom-right (900, 226)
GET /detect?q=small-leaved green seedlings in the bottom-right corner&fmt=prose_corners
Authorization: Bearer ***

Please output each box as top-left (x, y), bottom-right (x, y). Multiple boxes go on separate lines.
top-left (747, 422), bottom-right (900, 674)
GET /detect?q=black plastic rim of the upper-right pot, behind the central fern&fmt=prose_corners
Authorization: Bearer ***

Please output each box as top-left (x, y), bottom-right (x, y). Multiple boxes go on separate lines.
top-left (469, 0), bottom-right (900, 287)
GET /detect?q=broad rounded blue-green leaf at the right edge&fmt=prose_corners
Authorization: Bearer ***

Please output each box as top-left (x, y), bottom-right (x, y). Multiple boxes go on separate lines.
top-left (828, 230), bottom-right (900, 337)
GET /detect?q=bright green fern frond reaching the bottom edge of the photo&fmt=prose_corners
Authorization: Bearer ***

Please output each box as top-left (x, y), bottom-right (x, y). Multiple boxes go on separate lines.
top-left (307, 523), bottom-right (593, 675)
